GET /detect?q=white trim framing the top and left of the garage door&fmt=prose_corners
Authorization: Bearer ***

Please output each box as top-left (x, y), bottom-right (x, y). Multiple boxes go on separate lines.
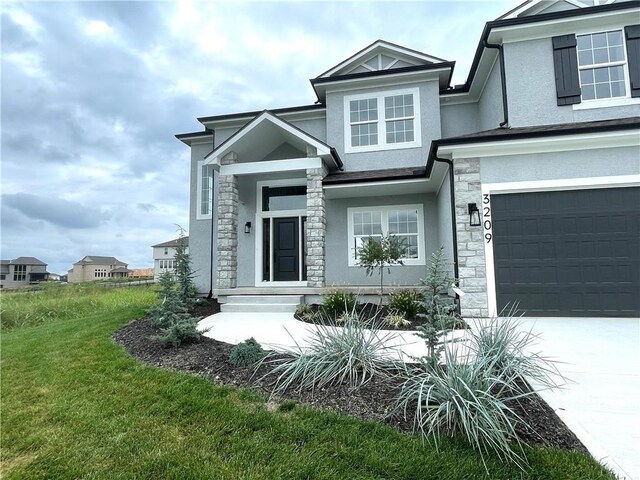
top-left (481, 174), bottom-right (640, 315)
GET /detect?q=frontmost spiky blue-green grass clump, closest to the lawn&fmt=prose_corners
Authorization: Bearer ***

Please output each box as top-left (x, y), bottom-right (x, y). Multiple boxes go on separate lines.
top-left (395, 349), bottom-right (527, 473)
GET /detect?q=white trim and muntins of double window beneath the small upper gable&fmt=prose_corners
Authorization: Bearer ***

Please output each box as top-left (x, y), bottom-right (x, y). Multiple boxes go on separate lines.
top-left (344, 88), bottom-right (422, 153)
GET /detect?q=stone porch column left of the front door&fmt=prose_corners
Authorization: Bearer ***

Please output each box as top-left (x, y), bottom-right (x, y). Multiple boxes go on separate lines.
top-left (216, 152), bottom-right (238, 288)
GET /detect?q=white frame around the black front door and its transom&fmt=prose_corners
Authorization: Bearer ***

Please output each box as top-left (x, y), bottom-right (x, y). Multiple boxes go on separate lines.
top-left (252, 178), bottom-right (307, 287)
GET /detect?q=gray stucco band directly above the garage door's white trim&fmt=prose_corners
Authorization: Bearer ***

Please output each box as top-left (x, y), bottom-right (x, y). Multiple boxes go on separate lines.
top-left (480, 147), bottom-right (640, 183)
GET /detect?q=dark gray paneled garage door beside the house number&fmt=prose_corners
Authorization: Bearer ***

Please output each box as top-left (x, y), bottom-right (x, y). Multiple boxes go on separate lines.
top-left (491, 187), bottom-right (640, 317)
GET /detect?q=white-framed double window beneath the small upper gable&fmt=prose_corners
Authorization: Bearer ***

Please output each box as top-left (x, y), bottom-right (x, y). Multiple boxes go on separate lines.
top-left (344, 88), bottom-right (420, 153)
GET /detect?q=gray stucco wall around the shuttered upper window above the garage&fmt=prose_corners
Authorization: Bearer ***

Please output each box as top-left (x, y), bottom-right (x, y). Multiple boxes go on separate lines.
top-left (504, 37), bottom-right (640, 127)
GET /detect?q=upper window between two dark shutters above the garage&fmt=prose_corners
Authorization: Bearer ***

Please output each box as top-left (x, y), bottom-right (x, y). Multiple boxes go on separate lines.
top-left (577, 30), bottom-right (628, 100)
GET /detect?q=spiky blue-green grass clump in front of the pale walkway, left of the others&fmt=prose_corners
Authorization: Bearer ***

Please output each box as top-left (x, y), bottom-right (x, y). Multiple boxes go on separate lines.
top-left (266, 319), bottom-right (399, 393)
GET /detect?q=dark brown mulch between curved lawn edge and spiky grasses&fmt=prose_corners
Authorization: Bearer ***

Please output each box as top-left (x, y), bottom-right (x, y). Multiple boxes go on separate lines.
top-left (113, 316), bottom-right (587, 452)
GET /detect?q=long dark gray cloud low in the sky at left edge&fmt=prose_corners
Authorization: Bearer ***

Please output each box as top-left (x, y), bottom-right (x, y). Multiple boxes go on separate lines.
top-left (2, 193), bottom-right (104, 228)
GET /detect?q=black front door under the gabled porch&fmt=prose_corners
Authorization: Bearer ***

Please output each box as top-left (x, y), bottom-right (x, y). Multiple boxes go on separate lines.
top-left (273, 217), bottom-right (300, 282)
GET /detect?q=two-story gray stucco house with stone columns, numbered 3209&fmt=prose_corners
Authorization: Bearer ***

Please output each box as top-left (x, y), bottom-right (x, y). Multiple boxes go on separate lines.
top-left (177, 0), bottom-right (640, 316)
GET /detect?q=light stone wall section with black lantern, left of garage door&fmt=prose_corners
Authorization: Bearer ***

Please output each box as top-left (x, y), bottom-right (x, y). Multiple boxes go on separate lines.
top-left (453, 158), bottom-right (488, 317)
